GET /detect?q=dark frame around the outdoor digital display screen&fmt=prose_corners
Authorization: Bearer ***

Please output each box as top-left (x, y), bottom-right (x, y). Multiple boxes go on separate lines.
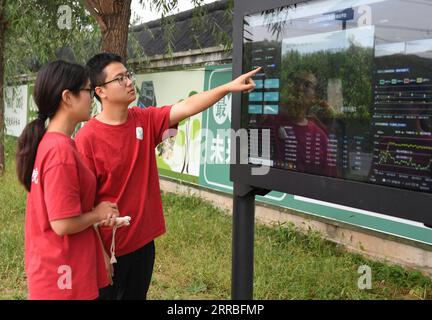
top-left (230, 0), bottom-right (432, 224)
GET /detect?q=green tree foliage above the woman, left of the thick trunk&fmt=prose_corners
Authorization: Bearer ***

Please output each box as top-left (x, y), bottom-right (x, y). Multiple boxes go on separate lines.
top-left (5, 0), bottom-right (100, 82)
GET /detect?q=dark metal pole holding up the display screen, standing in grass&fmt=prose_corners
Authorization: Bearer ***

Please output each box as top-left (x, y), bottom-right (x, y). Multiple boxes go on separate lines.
top-left (231, 183), bottom-right (270, 300)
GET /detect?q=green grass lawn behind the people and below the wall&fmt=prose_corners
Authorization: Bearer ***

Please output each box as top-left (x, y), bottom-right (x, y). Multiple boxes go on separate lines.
top-left (0, 139), bottom-right (432, 299)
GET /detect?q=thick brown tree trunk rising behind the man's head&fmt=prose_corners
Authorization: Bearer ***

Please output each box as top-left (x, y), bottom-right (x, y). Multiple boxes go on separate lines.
top-left (84, 0), bottom-right (132, 62)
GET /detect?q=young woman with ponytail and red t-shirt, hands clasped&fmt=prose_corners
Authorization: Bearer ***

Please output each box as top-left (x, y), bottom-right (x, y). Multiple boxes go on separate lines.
top-left (16, 61), bottom-right (119, 299)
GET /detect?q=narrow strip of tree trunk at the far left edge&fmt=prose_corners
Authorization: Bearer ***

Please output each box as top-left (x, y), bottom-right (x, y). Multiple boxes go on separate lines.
top-left (0, 0), bottom-right (6, 176)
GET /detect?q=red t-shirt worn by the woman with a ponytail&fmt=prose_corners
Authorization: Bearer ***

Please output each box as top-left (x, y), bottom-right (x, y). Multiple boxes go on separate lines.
top-left (25, 132), bottom-right (108, 300)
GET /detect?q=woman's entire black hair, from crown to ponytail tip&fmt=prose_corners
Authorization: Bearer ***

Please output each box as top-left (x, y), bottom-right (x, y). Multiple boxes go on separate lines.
top-left (16, 60), bottom-right (89, 192)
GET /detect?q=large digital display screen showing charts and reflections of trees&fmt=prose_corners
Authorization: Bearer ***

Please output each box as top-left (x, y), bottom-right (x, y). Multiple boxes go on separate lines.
top-left (241, 0), bottom-right (432, 193)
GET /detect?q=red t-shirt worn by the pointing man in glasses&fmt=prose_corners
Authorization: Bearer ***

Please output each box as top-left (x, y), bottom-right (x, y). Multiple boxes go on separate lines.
top-left (75, 106), bottom-right (177, 256)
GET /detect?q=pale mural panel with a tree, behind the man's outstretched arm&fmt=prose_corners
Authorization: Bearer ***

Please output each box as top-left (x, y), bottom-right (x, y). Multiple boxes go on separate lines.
top-left (135, 68), bottom-right (204, 183)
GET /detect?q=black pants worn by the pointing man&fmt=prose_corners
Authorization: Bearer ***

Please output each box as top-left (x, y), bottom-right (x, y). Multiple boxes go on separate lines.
top-left (98, 241), bottom-right (155, 300)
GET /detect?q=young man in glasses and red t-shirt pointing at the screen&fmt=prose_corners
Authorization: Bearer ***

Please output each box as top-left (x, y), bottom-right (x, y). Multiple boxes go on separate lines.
top-left (75, 53), bottom-right (259, 300)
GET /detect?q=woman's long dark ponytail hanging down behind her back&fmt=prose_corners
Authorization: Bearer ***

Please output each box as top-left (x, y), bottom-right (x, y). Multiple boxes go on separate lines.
top-left (16, 116), bottom-right (46, 192)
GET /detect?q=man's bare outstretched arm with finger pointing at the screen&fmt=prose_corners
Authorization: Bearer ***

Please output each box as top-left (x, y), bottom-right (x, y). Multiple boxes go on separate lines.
top-left (170, 68), bottom-right (261, 126)
